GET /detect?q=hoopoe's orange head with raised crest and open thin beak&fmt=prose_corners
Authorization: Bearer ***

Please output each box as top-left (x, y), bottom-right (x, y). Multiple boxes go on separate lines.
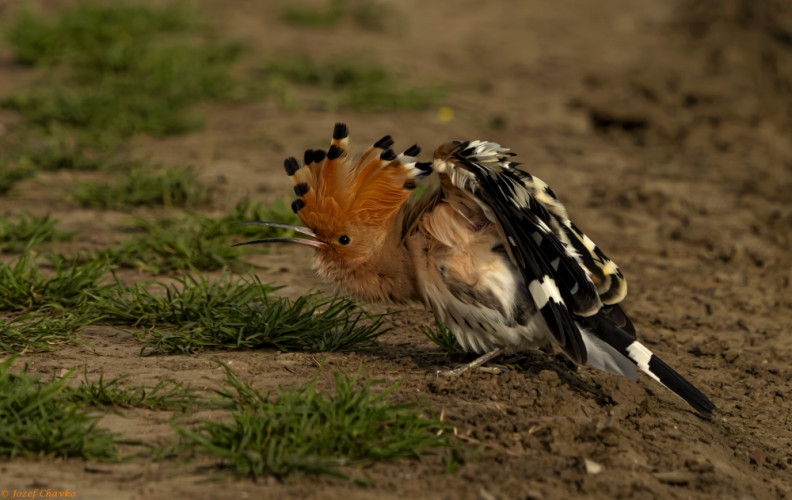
top-left (234, 123), bottom-right (431, 271)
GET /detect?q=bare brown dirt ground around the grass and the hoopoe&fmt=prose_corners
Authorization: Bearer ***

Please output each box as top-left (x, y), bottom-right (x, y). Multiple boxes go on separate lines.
top-left (0, 0), bottom-right (792, 500)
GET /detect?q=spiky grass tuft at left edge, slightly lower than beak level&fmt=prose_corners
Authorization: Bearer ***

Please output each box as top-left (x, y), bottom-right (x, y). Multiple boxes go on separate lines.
top-left (0, 253), bottom-right (107, 312)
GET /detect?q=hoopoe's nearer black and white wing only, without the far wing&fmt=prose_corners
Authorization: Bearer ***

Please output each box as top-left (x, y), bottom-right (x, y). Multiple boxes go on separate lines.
top-left (435, 141), bottom-right (602, 363)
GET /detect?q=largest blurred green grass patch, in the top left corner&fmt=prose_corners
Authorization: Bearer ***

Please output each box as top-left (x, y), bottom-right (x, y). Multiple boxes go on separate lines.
top-left (0, 2), bottom-right (242, 142)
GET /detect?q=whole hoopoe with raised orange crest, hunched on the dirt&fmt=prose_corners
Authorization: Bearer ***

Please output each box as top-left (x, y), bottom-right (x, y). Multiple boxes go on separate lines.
top-left (238, 123), bottom-right (716, 417)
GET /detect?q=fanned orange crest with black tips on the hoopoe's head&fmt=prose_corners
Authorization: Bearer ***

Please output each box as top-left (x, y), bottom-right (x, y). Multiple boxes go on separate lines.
top-left (284, 123), bottom-right (431, 235)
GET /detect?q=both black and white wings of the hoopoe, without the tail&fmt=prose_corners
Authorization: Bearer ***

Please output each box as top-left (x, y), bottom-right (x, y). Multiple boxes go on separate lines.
top-left (434, 141), bottom-right (626, 363)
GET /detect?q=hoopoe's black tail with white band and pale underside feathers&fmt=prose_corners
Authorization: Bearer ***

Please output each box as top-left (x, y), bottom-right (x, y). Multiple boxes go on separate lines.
top-left (578, 311), bottom-right (717, 418)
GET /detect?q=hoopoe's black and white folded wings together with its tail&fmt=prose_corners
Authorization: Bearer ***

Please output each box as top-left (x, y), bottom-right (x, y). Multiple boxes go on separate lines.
top-left (434, 141), bottom-right (716, 417)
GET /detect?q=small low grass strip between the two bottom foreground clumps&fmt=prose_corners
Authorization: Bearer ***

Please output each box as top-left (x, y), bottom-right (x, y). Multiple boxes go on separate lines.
top-left (65, 368), bottom-right (205, 411)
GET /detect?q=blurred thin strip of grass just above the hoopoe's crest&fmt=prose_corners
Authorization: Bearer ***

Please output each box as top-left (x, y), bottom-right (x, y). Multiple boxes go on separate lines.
top-left (262, 58), bottom-right (445, 112)
